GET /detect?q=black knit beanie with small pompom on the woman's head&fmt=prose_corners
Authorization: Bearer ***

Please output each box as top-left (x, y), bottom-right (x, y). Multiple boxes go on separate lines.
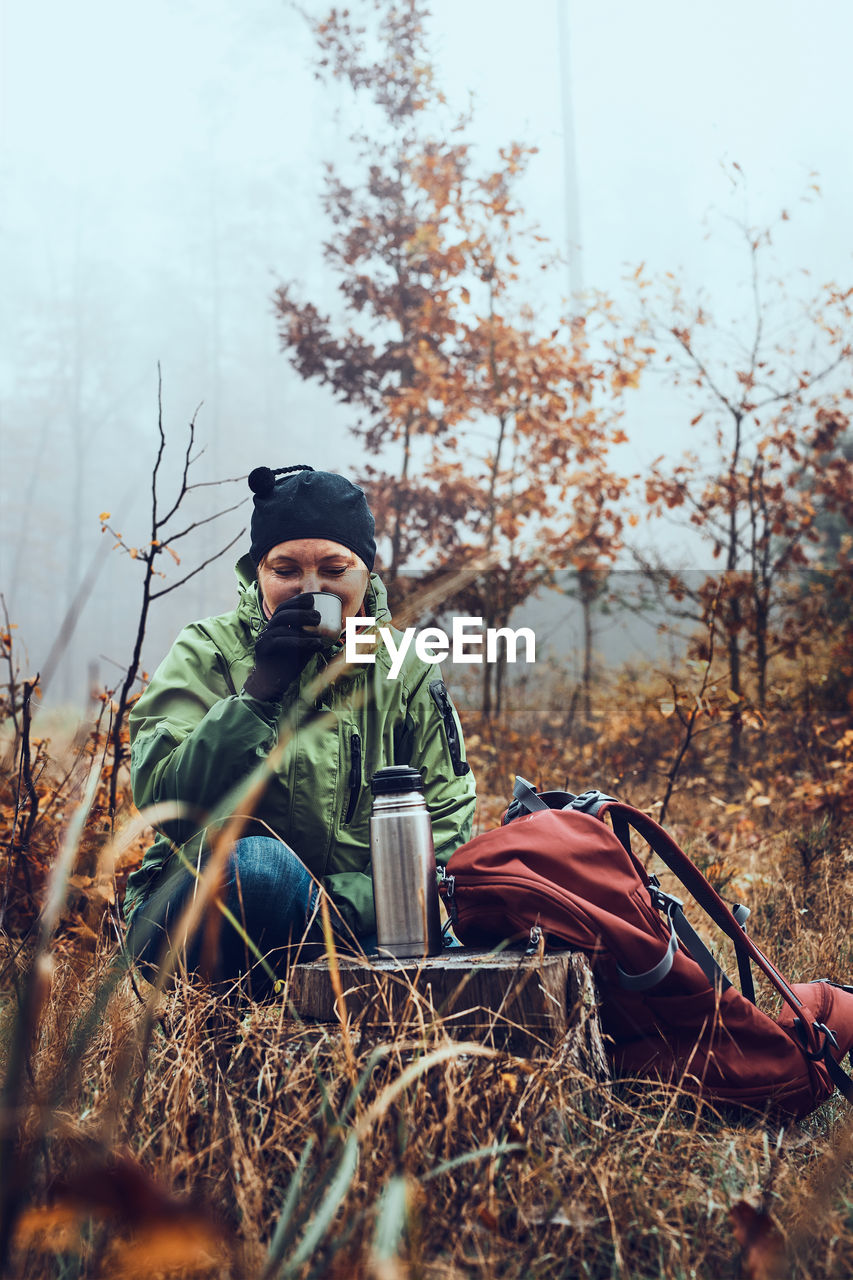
top-left (248, 466), bottom-right (377, 570)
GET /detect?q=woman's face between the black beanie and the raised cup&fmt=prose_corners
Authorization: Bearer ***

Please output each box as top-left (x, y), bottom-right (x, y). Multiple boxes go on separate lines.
top-left (257, 538), bottom-right (370, 622)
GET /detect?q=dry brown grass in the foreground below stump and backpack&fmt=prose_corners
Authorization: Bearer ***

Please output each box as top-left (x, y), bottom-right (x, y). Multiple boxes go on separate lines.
top-left (4, 839), bottom-right (853, 1280)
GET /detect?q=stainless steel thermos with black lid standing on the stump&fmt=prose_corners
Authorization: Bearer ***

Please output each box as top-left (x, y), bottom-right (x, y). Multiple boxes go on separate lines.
top-left (370, 764), bottom-right (442, 956)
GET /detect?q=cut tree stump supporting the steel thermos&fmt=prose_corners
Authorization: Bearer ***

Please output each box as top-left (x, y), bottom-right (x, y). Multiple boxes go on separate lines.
top-left (287, 947), bottom-right (610, 1082)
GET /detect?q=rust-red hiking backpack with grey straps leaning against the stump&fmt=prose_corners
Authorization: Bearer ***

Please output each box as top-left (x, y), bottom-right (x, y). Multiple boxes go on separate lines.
top-left (439, 778), bottom-right (853, 1117)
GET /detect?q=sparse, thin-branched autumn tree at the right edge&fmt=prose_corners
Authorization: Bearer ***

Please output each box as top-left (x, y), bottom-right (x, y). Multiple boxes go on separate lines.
top-left (644, 183), bottom-right (853, 769)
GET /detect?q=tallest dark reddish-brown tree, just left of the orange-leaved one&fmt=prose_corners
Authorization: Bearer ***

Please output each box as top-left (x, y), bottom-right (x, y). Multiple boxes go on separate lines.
top-left (275, 3), bottom-right (476, 581)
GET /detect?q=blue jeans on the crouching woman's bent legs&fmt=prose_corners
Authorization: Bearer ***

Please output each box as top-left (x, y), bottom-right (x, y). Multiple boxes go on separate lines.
top-left (128, 836), bottom-right (319, 996)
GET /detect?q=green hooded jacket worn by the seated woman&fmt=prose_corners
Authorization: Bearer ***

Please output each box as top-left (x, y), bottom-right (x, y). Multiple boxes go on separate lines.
top-left (124, 556), bottom-right (475, 934)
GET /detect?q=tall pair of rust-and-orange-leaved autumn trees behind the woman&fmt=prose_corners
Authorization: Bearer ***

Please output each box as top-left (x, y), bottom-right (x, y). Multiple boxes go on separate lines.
top-left (275, 0), bottom-right (642, 714)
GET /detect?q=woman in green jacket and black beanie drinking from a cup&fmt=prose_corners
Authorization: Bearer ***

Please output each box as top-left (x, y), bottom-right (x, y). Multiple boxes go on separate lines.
top-left (124, 467), bottom-right (475, 991)
